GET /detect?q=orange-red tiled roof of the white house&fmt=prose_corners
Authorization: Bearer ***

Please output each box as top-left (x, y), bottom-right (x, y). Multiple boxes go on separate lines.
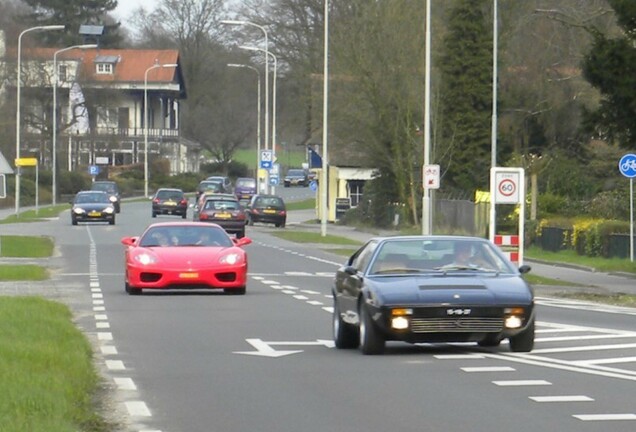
top-left (17, 48), bottom-right (179, 83)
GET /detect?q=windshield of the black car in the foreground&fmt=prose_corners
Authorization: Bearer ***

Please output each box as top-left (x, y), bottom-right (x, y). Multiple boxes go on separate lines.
top-left (369, 239), bottom-right (514, 274)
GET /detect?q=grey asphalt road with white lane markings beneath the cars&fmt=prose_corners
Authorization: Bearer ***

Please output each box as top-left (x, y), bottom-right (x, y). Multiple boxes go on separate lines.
top-left (0, 197), bottom-right (636, 432)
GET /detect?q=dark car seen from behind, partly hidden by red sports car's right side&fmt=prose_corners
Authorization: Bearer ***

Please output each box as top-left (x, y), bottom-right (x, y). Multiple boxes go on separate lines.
top-left (197, 194), bottom-right (246, 238)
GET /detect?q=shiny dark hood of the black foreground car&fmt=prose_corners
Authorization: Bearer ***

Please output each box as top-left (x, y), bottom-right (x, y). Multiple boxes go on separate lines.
top-left (367, 275), bottom-right (533, 305)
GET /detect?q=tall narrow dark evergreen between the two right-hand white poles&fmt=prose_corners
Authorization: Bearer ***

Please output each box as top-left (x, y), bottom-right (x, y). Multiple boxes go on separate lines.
top-left (436, 0), bottom-right (492, 191)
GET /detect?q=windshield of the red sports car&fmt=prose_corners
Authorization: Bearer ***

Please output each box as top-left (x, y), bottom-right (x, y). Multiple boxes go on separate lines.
top-left (139, 225), bottom-right (234, 247)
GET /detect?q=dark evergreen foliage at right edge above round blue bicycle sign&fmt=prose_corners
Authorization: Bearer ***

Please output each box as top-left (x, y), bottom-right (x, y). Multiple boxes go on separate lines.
top-left (582, 0), bottom-right (636, 148)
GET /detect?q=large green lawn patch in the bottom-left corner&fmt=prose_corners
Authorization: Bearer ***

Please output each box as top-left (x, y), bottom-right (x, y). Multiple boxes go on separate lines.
top-left (0, 297), bottom-right (113, 432)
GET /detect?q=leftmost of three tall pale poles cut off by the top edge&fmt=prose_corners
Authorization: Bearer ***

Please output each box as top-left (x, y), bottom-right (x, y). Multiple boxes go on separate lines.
top-left (320, 0), bottom-right (329, 237)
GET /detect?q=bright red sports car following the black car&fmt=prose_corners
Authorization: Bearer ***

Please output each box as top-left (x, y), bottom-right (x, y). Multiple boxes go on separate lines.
top-left (121, 222), bottom-right (252, 295)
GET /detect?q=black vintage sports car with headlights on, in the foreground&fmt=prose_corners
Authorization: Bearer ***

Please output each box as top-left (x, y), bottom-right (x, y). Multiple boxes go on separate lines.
top-left (332, 236), bottom-right (535, 354)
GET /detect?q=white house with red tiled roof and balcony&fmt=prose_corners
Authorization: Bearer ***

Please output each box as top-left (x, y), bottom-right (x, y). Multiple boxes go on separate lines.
top-left (0, 28), bottom-right (200, 174)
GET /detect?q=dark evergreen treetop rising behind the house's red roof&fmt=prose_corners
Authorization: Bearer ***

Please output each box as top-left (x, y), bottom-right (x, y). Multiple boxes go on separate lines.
top-left (19, 0), bottom-right (122, 47)
